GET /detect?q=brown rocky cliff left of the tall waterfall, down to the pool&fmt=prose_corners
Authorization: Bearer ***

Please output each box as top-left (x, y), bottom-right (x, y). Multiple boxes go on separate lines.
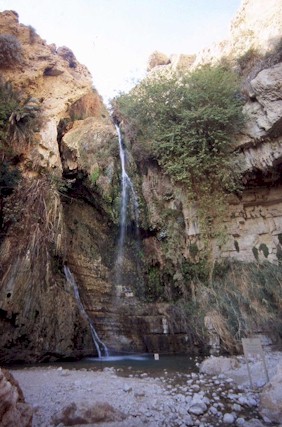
top-left (0, 11), bottom-right (192, 363)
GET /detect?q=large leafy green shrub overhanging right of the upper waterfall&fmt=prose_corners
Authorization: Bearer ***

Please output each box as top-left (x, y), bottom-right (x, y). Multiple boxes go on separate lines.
top-left (113, 66), bottom-right (244, 239)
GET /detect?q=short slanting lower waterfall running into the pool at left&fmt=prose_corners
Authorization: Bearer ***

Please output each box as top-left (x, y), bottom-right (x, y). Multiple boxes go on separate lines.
top-left (64, 265), bottom-right (109, 359)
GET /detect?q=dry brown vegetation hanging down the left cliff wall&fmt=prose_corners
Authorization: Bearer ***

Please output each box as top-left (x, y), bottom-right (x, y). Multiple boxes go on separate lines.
top-left (1, 176), bottom-right (64, 288)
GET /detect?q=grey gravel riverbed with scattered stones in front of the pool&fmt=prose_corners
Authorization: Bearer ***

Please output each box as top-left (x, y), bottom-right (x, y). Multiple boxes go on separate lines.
top-left (10, 352), bottom-right (282, 427)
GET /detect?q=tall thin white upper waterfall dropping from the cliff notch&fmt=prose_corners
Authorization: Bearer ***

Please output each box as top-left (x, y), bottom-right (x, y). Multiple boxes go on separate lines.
top-left (116, 125), bottom-right (139, 284)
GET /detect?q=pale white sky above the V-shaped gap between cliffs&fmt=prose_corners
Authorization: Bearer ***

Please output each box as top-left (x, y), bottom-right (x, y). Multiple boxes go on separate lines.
top-left (0, 0), bottom-right (241, 102)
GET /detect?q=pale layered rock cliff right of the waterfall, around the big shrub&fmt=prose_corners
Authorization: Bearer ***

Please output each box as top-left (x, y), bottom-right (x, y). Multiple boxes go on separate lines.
top-left (117, 1), bottom-right (282, 352)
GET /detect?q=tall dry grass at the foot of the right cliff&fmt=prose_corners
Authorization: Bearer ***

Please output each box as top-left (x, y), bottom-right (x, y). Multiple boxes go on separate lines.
top-left (171, 262), bottom-right (282, 353)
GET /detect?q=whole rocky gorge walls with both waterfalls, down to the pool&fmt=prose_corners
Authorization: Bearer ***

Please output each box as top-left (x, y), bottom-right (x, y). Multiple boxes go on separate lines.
top-left (0, 0), bottom-right (282, 364)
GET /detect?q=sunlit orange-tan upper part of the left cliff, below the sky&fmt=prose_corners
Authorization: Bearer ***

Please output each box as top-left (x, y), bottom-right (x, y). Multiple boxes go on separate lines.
top-left (0, 11), bottom-right (92, 169)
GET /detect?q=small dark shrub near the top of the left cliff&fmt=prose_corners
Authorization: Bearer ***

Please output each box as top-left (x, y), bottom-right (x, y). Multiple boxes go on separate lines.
top-left (0, 34), bottom-right (22, 68)
